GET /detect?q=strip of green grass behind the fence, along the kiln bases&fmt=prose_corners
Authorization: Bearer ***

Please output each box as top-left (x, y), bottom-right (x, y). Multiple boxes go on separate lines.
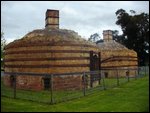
top-left (1, 78), bottom-right (132, 103)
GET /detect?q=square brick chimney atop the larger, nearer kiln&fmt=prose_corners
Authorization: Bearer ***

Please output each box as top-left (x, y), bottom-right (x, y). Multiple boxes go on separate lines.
top-left (45, 9), bottom-right (59, 29)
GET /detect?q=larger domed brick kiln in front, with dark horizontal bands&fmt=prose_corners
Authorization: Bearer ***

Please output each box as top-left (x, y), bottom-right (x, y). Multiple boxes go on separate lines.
top-left (4, 10), bottom-right (100, 90)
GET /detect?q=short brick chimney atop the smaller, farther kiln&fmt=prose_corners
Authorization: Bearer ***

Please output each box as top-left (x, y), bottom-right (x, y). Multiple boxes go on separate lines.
top-left (103, 30), bottom-right (113, 42)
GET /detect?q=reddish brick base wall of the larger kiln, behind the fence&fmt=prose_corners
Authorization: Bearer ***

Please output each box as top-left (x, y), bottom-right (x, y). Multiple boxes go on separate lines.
top-left (4, 75), bottom-right (82, 90)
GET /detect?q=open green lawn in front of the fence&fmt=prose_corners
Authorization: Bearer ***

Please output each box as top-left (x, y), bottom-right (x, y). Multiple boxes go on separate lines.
top-left (1, 76), bottom-right (149, 112)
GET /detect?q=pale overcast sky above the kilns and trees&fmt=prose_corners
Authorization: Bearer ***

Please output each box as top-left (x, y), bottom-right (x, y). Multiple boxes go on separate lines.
top-left (1, 1), bottom-right (149, 42)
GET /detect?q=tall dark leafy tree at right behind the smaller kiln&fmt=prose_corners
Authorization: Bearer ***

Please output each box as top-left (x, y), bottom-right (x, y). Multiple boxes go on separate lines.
top-left (116, 9), bottom-right (149, 65)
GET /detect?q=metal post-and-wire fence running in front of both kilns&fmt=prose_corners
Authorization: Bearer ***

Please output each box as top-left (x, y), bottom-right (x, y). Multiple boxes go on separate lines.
top-left (1, 67), bottom-right (149, 104)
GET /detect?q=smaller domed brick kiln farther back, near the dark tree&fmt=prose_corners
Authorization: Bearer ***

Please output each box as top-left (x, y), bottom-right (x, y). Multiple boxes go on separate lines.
top-left (97, 30), bottom-right (138, 77)
